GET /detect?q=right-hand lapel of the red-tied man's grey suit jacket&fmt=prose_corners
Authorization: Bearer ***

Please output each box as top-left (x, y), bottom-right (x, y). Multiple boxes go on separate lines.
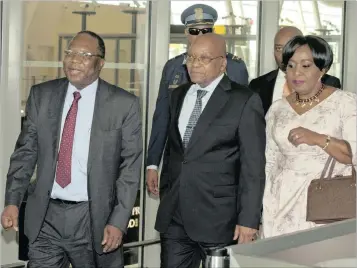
top-left (87, 79), bottom-right (110, 174)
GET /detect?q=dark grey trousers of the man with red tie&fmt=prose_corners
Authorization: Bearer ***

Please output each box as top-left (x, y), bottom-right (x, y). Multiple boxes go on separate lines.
top-left (28, 200), bottom-right (124, 268)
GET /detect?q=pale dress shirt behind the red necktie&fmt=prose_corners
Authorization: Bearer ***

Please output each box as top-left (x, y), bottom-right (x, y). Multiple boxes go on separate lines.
top-left (51, 79), bottom-right (98, 201)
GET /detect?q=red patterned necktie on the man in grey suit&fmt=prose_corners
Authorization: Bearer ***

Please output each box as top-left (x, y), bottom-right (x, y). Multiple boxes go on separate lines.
top-left (56, 92), bottom-right (81, 188)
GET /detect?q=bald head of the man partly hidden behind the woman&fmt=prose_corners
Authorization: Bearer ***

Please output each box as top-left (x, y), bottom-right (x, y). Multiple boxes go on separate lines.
top-left (274, 26), bottom-right (303, 69)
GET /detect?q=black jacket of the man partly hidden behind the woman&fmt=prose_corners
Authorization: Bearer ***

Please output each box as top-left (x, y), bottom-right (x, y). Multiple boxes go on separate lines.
top-left (249, 69), bottom-right (341, 114)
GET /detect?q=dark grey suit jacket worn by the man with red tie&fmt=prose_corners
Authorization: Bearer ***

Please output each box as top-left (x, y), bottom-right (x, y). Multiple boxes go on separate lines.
top-left (5, 78), bottom-right (142, 253)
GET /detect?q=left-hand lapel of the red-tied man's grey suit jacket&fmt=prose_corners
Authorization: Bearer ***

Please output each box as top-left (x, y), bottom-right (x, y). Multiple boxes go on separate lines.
top-left (48, 79), bottom-right (68, 164)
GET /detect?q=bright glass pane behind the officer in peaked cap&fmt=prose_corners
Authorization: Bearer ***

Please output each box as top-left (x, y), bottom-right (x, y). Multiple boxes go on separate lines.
top-left (169, 0), bottom-right (258, 79)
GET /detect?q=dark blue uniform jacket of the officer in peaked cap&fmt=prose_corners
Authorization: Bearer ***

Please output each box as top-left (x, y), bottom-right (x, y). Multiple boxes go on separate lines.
top-left (146, 53), bottom-right (248, 170)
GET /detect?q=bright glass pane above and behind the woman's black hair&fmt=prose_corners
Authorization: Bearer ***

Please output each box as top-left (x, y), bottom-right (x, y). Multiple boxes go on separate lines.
top-left (279, 0), bottom-right (344, 79)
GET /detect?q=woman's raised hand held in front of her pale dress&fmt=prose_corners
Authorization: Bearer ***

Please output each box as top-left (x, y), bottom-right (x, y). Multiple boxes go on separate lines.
top-left (288, 127), bottom-right (326, 147)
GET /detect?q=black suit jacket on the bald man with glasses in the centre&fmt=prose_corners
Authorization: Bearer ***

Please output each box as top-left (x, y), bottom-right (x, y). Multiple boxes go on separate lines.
top-left (155, 76), bottom-right (265, 243)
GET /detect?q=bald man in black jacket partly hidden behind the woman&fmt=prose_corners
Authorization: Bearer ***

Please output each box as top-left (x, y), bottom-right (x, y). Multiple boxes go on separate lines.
top-left (249, 26), bottom-right (341, 114)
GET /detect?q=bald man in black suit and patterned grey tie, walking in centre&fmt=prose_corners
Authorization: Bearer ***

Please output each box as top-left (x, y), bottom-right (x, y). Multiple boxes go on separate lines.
top-left (155, 34), bottom-right (265, 268)
